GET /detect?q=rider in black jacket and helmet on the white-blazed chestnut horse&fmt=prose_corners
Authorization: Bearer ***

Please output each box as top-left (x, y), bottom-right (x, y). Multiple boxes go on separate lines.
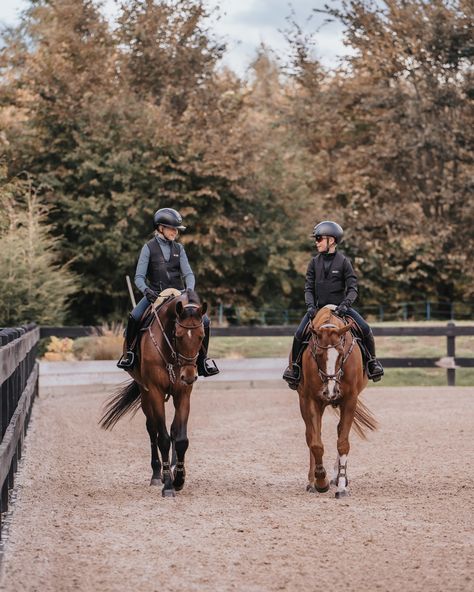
top-left (283, 220), bottom-right (383, 389)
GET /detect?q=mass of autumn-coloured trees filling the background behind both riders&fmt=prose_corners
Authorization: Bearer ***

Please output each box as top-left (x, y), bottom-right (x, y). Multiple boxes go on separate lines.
top-left (0, 0), bottom-right (474, 323)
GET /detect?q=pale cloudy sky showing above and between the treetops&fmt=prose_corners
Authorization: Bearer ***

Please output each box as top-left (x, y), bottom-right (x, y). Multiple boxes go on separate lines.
top-left (0, 0), bottom-right (347, 76)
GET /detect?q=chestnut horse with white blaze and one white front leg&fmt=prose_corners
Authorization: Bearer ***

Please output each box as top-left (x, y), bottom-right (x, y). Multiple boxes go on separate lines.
top-left (298, 305), bottom-right (377, 498)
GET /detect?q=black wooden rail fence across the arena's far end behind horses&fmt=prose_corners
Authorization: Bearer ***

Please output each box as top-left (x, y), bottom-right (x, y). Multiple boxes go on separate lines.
top-left (41, 323), bottom-right (474, 386)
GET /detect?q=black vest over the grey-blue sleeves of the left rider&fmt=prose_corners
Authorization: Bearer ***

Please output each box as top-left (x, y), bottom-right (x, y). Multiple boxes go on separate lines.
top-left (146, 238), bottom-right (184, 292)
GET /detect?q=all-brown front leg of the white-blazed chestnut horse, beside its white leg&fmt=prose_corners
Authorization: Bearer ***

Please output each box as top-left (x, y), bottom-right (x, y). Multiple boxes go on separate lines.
top-left (300, 400), bottom-right (329, 493)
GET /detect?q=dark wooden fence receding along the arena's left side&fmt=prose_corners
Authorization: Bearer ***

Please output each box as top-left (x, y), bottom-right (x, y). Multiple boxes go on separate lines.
top-left (0, 324), bottom-right (40, 537)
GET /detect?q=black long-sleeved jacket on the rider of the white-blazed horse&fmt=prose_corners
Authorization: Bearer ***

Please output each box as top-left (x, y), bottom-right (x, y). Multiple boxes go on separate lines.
top-left (304, 251), bottom-right (358, 308)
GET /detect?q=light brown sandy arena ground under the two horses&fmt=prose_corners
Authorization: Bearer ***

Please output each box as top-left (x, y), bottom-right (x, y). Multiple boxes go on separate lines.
top-left (0, 381), bottom-right (474, 592)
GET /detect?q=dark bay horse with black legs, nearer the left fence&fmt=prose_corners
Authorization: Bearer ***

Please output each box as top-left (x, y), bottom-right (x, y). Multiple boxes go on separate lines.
top-left (99, 290), bottom-right (207, 497)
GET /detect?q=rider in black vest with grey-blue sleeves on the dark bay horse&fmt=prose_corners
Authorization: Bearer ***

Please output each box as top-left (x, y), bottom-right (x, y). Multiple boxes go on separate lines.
top-left (117, 208), bottom-right (219, 376)
